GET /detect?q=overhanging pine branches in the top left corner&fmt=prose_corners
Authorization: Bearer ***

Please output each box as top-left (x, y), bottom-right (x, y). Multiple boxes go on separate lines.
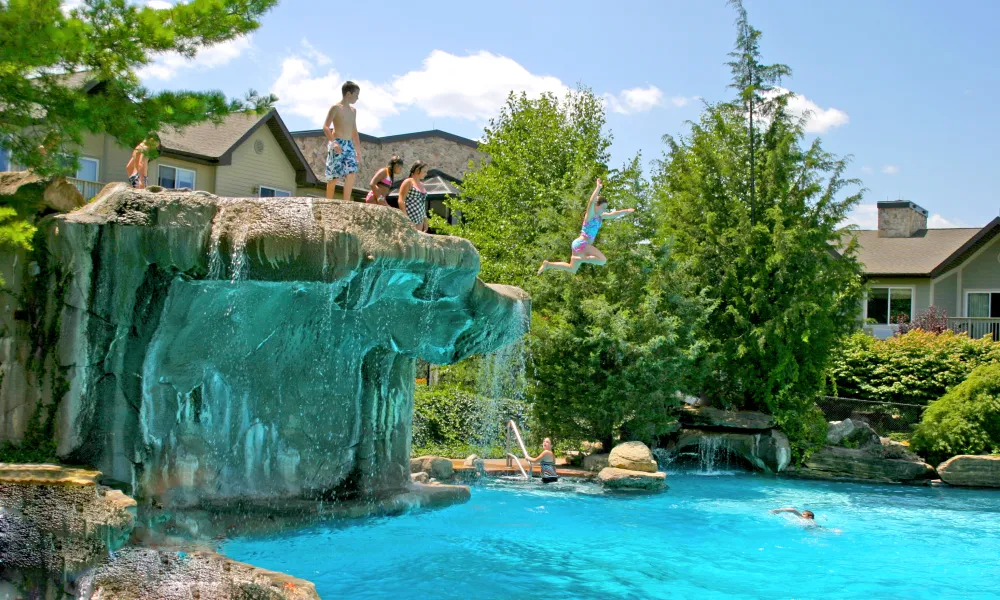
top-left (0, 0), bottom-right (277, 175)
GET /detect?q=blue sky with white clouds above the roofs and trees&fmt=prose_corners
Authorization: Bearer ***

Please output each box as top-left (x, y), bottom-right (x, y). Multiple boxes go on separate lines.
top-left (125, 0), bottom-right (1000, 228)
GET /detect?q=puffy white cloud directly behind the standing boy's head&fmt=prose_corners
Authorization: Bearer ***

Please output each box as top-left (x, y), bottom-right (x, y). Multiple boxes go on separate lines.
top-left (271, 54), bottom-right (399, 133)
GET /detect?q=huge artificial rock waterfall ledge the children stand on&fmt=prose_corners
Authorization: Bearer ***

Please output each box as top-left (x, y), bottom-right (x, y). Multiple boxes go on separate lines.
top-left (0, 184), bottom-right (530, 505)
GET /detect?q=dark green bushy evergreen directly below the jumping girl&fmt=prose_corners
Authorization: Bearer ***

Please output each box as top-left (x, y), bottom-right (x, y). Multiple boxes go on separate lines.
top-left (528, 157), bottom-right (711, 448)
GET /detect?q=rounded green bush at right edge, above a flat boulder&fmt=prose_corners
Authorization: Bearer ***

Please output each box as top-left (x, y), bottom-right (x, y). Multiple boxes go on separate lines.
top-left (911, 364), bottom-right (1000, 464)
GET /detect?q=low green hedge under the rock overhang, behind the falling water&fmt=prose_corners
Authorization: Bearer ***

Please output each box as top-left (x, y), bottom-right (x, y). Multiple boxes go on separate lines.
top-left (412, 384), bottom-right (527, 458)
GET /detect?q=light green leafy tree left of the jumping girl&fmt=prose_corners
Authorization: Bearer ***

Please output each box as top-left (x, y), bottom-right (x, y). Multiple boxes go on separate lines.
top-left (433, 89), bottom-right (613, 285)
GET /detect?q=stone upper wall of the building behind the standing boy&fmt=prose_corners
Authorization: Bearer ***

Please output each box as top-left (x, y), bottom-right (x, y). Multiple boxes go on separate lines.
top-left (295, 133), bottom-right (487, 190)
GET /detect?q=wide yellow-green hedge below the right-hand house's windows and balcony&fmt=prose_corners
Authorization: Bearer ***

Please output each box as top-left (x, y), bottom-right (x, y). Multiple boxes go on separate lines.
top-left (830, 329), bottom-right (1000, 404)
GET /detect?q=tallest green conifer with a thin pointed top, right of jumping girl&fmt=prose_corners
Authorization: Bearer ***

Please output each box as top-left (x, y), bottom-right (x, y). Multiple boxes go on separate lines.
top-left (654, 3), bottom-right (862, 456)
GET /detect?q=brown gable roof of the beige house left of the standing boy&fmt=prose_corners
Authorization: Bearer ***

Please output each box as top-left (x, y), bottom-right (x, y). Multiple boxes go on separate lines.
top-left (159, 109), bottom-right (318, 184)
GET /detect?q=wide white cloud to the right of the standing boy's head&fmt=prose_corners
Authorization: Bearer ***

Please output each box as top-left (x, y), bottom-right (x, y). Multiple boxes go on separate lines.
top-left (391, 50), bottom-right (569, 120)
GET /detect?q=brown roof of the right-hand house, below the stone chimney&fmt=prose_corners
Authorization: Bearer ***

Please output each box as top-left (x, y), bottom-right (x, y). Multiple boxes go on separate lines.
top-left (852, 217), bottom-right (1000, 277)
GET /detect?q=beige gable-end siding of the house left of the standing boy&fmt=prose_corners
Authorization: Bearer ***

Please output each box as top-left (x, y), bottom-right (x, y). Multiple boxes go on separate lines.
top-left (215, 127), bottom-right (297, 198)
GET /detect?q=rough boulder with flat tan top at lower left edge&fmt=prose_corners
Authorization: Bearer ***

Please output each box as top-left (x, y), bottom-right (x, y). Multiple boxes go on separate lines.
top-left (0, 464), bottom-right (136, 576)
